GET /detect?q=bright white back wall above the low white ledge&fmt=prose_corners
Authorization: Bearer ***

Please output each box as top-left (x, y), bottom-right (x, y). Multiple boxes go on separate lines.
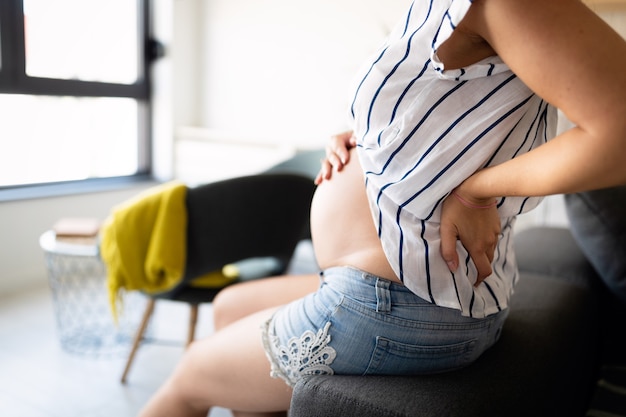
top-left (201, 0), bottom-right (410, 147)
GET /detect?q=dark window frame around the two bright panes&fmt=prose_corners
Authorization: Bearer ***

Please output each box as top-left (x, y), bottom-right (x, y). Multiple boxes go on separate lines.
top-left (0, 0), bottom-right (155, 201)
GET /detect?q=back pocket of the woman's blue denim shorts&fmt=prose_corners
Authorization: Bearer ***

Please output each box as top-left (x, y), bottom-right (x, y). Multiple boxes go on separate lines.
top-left (365, 336), bottom-right (476, 375)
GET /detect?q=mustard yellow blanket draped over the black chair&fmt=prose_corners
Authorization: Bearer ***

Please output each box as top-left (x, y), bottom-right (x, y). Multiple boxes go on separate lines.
top-left (100, 182), bottom-right (187, 318)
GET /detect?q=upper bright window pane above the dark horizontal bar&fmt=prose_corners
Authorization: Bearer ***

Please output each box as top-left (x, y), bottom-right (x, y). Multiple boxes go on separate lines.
top-left (24, 0), bottom-right (140, 84)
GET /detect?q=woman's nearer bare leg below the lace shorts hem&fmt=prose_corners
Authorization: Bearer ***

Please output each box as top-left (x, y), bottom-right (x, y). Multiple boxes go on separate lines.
top-left (140, 309), bottom-right (291, 417)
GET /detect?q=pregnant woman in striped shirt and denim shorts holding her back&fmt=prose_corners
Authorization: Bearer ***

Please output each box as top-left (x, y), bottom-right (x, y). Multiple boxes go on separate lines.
top-left (142, 0), bottom-right (626, 416)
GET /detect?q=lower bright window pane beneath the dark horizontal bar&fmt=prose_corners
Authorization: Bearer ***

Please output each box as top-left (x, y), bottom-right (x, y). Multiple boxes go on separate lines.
top-left (0, 95), bottom-right (139, 186)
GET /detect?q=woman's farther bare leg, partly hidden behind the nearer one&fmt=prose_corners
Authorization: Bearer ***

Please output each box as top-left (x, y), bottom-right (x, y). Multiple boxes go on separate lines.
top-left (212, 274), bottom-right (320, 330)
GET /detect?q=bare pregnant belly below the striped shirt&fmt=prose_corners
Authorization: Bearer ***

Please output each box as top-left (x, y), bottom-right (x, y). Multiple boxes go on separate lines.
top-left (311, 152), bottom-right (398, 281)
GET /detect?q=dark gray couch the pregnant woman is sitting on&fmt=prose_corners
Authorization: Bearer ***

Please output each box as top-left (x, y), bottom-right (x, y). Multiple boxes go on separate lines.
top-left (289, 187), bottom-right (626, 417)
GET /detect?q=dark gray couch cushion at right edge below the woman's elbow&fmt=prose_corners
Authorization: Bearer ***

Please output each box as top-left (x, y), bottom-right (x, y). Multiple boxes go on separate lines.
top-left (565, 186), bottom-right (626, 303)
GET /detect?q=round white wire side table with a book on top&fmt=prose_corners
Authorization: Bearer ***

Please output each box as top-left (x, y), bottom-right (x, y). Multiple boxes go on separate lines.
top-left (39, 230), bottom-right (147, 357)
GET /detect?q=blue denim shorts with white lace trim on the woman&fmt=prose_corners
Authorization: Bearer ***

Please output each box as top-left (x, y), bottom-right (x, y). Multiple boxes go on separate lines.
top-left (263, 267), bottom-right (508, 386)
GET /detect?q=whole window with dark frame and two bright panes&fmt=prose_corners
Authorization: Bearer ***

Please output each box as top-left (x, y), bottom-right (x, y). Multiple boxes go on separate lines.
top-left (0, 0), bottom-right (155, 193)
